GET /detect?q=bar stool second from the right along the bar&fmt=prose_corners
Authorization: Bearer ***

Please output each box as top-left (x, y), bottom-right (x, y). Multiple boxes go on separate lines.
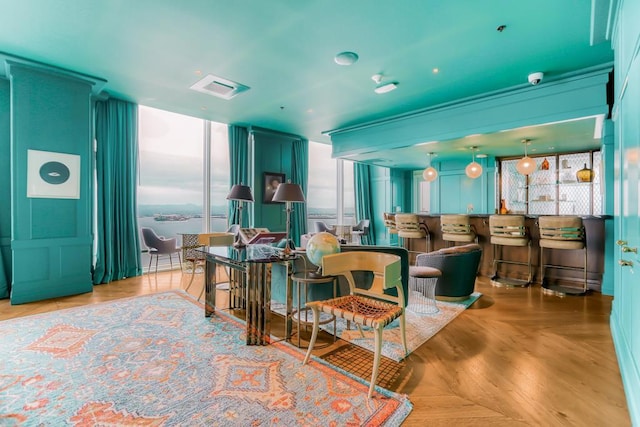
top-left (489, 215), bottom-right (533, 287)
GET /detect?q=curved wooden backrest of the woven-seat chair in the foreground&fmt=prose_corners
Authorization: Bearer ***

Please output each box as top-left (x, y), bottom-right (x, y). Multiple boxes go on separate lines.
top-left (322, 251), bottom-right (404, 306)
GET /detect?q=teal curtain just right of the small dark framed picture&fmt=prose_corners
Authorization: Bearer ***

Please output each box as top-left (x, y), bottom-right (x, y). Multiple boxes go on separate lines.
top-left (291, 139), bottom-right (309, 246)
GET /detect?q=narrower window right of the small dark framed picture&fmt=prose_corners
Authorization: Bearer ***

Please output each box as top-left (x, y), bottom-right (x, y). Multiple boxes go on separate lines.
top-left (307, 141), bottom-right (355, 232)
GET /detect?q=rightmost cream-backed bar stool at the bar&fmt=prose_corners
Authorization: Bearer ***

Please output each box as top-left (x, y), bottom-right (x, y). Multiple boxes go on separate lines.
top-left (538, 216), bottom-right (589, 296)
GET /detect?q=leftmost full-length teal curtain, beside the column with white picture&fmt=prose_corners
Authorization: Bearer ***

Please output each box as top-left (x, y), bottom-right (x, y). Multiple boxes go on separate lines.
top-left (93, 99), bottom-right (142, 284)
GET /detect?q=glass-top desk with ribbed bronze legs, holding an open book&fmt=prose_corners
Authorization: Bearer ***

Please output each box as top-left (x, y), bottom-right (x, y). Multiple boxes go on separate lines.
top-left (202, 245), bottom-right (294, 345)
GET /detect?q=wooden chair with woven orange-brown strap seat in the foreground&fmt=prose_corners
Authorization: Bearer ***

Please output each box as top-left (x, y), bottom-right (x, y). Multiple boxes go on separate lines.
top-left (302, 251), bottom-right (408, 398)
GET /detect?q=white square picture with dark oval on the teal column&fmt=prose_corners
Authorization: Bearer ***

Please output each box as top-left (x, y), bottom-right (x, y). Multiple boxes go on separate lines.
top-left (27, 150), bottom-right (80, 199)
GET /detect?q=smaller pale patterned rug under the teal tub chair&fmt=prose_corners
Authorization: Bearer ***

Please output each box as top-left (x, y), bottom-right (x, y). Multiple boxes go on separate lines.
top-left (280, 292), bottom-right (482, 362)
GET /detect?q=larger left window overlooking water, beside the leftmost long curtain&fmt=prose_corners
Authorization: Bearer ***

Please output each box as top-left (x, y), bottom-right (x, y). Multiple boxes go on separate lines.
top-left (138, 106), bottom-right (229, 267)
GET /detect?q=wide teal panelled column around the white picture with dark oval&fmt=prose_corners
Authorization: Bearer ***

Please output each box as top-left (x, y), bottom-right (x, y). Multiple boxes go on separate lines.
top-left (7, 61), bottom-right (93, 304)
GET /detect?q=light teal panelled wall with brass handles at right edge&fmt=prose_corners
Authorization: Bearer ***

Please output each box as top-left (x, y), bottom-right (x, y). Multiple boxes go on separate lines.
top-left (607, 0), bottom-right (640, 426)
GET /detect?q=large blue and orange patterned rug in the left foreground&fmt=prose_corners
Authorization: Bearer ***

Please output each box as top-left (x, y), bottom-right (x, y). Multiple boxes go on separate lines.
top-left (0, 291), bottom-right (412, 426)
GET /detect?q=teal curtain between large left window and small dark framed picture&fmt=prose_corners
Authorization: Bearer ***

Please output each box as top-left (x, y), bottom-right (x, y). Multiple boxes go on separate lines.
top-left (227, 125), bottom-right (250, 227)
